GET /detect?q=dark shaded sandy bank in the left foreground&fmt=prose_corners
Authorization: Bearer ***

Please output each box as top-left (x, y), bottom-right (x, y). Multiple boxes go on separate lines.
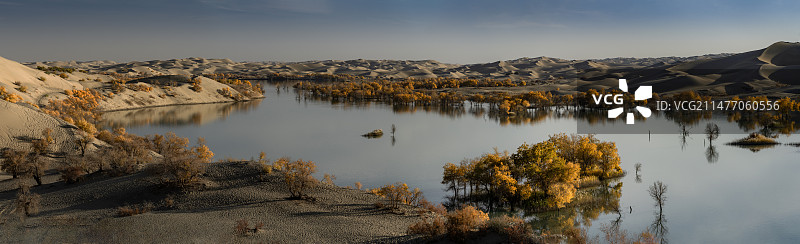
top-left (0, 163), bottom-right (418, 243)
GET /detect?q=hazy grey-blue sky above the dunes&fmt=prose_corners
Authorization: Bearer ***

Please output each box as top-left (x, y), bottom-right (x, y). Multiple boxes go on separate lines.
top-left (0, 0), bottom-right (800, 64)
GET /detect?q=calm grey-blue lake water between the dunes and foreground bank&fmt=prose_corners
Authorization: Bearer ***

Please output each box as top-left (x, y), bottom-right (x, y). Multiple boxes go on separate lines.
top-left (106, 83), bottom-right (800, 243)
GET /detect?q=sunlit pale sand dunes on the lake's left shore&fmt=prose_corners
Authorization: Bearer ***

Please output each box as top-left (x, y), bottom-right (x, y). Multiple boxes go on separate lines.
top-left (0, 57), bottom-right (264, 172)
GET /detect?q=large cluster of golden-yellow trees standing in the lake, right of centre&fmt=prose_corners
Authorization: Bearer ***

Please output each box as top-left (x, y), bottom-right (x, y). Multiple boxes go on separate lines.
top-left (442, 133), bottom-right (624, 212)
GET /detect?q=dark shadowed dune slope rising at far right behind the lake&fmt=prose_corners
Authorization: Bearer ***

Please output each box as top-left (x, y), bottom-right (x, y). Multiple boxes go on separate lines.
top-left (580, 42), bottom-right (800, 96)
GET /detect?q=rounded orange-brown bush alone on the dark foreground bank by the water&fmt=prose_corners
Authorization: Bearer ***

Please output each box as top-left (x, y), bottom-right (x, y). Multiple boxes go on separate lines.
top-left (279, 159), bottom-right (318, 199)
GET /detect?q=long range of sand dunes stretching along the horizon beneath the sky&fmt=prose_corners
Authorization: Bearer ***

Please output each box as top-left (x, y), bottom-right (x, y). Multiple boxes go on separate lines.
top-left (21, 42), bottom-right (800, 95)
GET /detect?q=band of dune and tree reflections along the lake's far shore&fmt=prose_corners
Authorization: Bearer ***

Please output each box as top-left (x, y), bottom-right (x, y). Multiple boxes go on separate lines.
top-left (104, 82), bottom-right (800, 138)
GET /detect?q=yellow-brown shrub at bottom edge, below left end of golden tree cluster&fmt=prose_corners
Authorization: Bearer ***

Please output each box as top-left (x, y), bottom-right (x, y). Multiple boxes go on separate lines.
top-left (447, 205), bottom-right (489, 240)
